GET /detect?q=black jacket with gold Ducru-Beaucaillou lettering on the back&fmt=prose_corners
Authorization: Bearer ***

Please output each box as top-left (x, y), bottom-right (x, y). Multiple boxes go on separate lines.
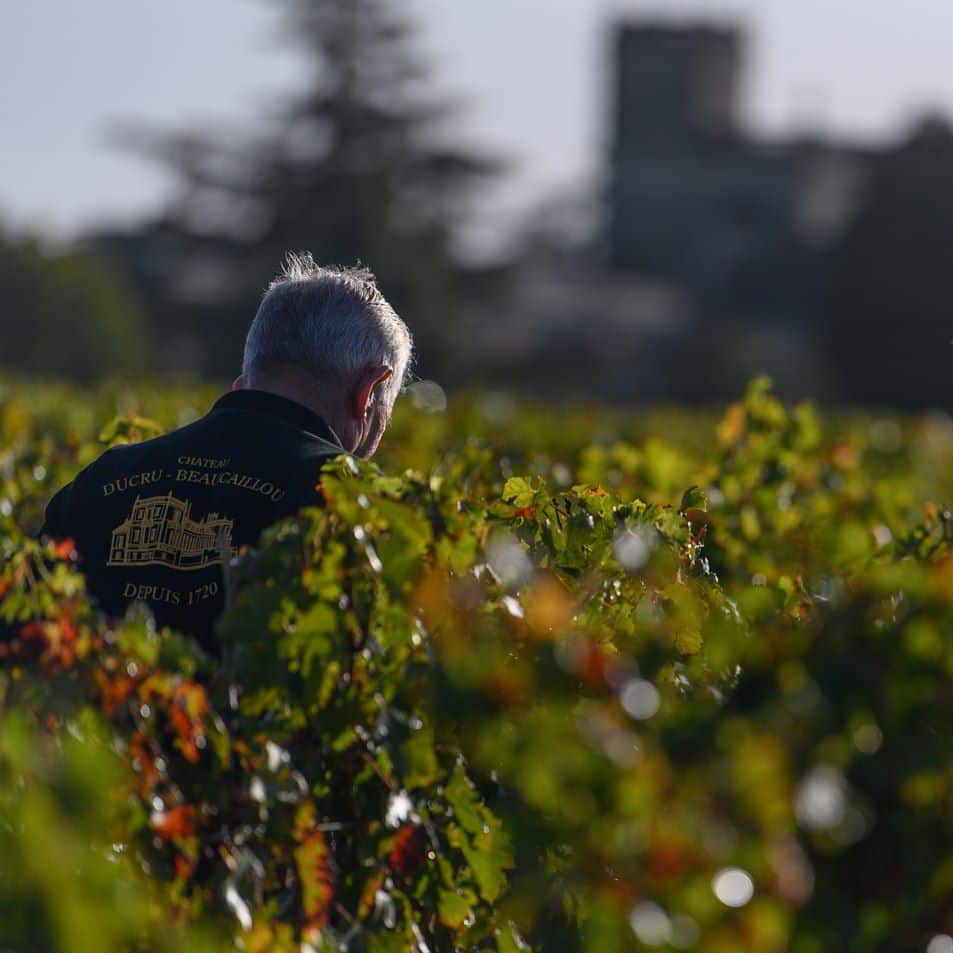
top-left (41, 390), bottom-right (345, 652)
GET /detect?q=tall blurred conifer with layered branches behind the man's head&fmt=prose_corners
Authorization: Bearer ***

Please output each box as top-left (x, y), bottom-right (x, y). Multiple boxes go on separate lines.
top-left (99, 0), bottom-right (497, 375)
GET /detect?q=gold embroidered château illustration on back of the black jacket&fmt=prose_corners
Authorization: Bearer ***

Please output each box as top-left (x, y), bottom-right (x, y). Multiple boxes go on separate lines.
top-left (107, 493), bottom-right (232, 569)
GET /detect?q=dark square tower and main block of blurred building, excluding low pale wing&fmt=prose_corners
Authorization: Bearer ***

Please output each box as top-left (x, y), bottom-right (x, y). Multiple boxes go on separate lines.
top-left (606, 24), bottom-right (873, 398)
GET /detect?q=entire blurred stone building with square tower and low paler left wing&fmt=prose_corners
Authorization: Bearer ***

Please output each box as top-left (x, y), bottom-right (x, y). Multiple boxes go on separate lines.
top-left (471, 23), bottom-right (912, 401)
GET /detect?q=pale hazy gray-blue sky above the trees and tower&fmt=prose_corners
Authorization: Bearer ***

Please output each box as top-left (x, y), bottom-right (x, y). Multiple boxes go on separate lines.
top-left (0, 0), bottom-right (953, 245)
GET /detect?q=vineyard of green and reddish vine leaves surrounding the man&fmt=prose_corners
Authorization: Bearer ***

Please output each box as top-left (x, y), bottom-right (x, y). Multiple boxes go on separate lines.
top-left (0, 380), bottom-right (953, 953)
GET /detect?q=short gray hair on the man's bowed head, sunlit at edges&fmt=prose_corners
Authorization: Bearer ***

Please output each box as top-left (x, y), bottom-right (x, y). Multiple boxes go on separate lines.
top-left (242, 252), bottom-right (414, 405)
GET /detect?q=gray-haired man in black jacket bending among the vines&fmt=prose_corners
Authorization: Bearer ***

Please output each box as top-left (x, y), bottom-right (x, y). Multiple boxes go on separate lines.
top-left (41, 255), bottom-right (413, 652)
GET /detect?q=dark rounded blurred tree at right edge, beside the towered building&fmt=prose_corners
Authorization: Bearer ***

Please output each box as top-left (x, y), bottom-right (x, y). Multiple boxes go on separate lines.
top-left (829, 119), bottom-right (953, 407)
